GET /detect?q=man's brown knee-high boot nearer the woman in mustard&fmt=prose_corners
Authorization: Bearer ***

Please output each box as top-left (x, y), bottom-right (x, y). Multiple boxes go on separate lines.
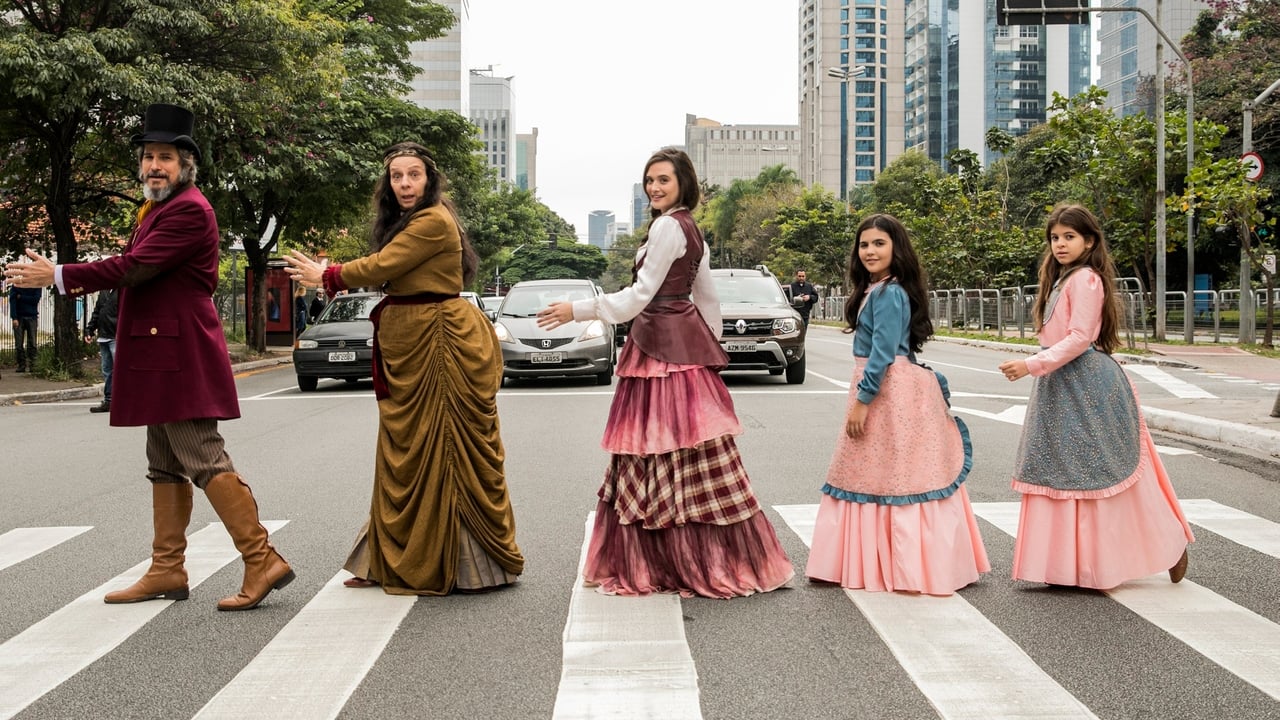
top-left (205, 473), bottom-right (293, 610)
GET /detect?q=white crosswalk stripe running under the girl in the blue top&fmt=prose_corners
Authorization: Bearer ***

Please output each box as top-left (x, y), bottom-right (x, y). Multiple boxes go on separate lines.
top-left (773, 505), bottom-right (1096, 720)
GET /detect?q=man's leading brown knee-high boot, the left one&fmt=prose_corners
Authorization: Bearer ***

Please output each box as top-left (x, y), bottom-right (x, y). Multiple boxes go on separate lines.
top-left (102, 483), bottom-right (191, 605)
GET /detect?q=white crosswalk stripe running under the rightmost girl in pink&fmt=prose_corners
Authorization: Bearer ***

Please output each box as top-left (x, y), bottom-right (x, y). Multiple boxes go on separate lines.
top-left (973, 502), bottom-right (1280, 700)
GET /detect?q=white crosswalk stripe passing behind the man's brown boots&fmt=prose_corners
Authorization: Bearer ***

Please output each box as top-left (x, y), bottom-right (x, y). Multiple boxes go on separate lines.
top-left (0, 520), bottom-right (288, 720)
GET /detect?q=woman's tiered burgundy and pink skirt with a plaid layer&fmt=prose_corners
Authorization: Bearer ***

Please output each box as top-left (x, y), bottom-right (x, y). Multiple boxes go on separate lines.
top-left (582, 343), bottom-right (795, 598)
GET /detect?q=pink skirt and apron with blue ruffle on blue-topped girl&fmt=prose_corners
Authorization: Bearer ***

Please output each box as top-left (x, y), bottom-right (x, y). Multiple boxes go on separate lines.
top-left (805, 357), bottom-right (991, 596)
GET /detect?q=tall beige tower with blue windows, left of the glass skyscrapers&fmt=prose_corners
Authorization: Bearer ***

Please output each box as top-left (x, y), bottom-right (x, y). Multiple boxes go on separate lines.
top-left (799, 0), bottom-right (906, 196)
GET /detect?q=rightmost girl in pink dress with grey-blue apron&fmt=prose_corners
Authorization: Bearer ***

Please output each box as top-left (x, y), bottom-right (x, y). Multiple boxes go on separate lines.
top-left (1000, 205), bottom-right (1194, 589)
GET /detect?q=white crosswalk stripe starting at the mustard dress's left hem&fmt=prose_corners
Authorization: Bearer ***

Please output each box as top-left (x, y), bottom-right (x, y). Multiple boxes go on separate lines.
top-left (196, 571), bottom-right (417, 720)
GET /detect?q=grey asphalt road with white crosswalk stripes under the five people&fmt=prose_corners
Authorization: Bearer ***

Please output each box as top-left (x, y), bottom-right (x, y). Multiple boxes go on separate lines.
top-left (0, 328), bottom-right (1280, 719)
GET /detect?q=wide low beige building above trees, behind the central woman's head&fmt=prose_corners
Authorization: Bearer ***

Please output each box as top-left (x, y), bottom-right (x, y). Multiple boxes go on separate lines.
top-left (685, 115), bottom-right (800, 187)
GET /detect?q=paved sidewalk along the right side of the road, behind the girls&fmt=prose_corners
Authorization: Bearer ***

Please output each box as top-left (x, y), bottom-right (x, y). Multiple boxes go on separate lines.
top-left (933, 336), bottom-right (1280, 460)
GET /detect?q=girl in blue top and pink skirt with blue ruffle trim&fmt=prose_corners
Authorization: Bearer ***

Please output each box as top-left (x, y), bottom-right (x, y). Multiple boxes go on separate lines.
top-left (805, 215), bottom-right (991, 594)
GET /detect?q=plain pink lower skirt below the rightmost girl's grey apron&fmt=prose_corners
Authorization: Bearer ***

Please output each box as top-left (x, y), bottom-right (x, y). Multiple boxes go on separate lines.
top-left (1014, 404), bottom-right (1196, 589)
